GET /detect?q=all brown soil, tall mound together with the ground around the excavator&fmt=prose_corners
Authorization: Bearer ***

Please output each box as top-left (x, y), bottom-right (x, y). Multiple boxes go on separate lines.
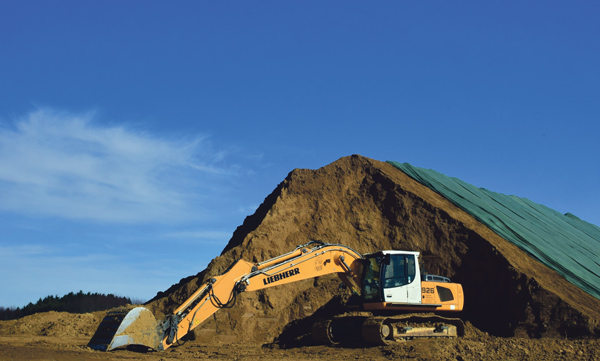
top-left (0, 155), bottom-right (600, 360)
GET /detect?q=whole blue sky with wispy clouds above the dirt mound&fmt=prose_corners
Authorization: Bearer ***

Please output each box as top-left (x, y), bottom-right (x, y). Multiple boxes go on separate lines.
top-left (0, 0), bottom-right (600, 307)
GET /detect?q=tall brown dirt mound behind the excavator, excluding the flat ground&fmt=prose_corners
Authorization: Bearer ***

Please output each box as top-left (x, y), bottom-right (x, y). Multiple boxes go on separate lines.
top-left (147, 155), bottom-right (600, 344)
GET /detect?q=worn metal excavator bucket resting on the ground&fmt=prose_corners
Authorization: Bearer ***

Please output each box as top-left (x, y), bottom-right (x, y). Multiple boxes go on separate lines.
top-left (88, 307), bottom-right (163, 351)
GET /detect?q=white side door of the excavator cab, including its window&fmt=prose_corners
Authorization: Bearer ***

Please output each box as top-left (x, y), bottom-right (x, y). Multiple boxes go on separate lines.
top-left (382, 254), bottom-right (421, 304)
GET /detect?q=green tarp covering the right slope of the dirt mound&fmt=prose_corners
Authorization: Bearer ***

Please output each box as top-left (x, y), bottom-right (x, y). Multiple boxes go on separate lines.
top-left (388, 161), bottom-right (600, 299)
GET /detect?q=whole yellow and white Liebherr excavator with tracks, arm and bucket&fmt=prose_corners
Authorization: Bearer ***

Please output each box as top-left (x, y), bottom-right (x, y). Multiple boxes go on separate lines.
top-left (88, 241), bottom-right (464, 351)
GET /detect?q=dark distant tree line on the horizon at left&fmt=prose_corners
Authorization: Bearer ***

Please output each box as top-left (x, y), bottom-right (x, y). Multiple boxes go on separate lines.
top-left (0, 291), bottom-right (141, 320)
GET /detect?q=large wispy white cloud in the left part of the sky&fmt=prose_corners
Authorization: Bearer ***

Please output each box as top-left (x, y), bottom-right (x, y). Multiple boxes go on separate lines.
top-left (0, 109), bottom-right (238, 223)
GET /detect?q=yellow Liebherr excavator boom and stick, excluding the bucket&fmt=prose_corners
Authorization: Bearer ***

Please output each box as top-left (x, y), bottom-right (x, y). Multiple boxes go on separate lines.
top-left (159, 241), bottom-right (362, 350)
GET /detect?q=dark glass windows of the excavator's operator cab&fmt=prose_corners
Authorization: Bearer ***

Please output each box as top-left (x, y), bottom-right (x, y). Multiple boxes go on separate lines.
top-left (363, 252), bottom-right (416, 302)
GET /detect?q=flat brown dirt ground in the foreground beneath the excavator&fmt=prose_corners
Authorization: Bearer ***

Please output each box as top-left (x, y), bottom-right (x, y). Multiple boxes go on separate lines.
top-left (0, 314), bottom-right (600, 361)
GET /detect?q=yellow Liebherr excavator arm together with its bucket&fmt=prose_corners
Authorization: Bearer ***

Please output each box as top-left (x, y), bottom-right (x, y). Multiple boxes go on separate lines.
top-left (88, 241), bottom-right (363, 351)
